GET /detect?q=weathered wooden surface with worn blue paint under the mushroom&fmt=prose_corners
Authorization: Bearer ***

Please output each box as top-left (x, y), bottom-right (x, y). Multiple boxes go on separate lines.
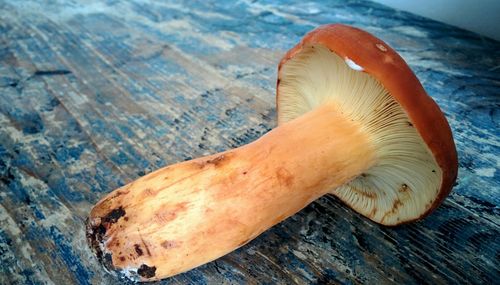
top-left (0, 0), bottom-right (500, 284)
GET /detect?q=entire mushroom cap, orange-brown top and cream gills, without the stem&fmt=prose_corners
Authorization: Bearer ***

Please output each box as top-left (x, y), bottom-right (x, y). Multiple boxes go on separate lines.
top-left (277, 25), bottom-right (457, 225)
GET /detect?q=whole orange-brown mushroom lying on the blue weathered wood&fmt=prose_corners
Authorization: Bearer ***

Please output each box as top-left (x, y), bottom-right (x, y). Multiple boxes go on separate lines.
top-left (87, 24), bottom-right (457, 281)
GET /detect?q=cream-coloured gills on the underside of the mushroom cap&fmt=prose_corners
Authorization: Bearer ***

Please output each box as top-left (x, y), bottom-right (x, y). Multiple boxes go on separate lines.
top-left (277, 44), bottom-right (442, 225)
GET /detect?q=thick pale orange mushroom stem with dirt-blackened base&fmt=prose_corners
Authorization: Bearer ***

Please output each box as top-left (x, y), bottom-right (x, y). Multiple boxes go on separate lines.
top-left (87, 102), bottom-right (374, 281)
